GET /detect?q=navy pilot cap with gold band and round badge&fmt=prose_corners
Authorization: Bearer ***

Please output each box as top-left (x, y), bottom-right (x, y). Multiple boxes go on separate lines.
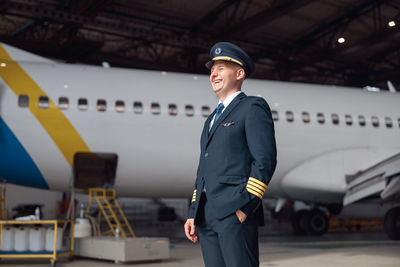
top-left (206, 42), bottom-right (254, 77)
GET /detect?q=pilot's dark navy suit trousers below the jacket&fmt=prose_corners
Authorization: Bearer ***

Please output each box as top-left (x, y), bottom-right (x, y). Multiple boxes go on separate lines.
top-left (197, 192), bottom-right (259, 267)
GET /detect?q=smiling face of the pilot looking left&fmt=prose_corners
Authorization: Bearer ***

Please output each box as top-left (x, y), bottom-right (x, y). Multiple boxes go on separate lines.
top-left (210, 61), bottom-right (245, 101)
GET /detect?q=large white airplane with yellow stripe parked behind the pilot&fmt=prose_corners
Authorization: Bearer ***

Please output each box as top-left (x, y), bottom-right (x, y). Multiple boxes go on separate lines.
top-left (0, 43), bottom-right (400, 239)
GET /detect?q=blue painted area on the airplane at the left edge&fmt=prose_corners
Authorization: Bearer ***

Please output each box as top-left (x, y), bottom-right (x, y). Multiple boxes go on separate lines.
top-left (0, 117), bottom-right (49, 189)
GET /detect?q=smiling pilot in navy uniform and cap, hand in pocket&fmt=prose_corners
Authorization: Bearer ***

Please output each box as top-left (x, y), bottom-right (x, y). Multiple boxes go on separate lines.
top-left (184, 42), bottom-right (276, 267)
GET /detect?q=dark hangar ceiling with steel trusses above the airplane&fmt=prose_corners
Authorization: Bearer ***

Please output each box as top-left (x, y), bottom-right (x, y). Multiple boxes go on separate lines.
top-left (0, 0), bottom-right (400, 89)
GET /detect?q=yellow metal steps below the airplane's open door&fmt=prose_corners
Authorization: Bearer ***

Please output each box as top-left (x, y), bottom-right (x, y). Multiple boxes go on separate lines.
top-left (86, 188), bottom-right (135, 237)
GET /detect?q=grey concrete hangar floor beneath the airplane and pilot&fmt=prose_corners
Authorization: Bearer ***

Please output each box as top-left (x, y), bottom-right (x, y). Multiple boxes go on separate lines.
top-left (0, 232), bottom-right (400, 267)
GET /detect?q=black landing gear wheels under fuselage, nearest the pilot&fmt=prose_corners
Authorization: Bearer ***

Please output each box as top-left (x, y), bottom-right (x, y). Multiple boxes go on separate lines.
top-left (292, 209), bottom-right (329, 235)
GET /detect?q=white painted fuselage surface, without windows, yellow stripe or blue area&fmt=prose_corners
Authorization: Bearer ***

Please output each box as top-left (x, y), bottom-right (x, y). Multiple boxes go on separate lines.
top-left (0, 44), bottom-right (400, 203)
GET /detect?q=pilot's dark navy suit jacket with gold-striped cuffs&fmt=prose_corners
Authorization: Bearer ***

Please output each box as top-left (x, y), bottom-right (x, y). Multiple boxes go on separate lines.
top-left (188, 93), bottom-right (276, 225)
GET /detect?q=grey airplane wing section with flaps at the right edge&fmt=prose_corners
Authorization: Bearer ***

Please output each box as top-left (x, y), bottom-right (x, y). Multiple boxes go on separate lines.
top-left (343, 153), bottom-right (400, 206)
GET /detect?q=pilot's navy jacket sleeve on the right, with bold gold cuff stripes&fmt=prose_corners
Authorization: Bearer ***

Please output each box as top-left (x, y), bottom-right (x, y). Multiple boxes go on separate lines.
top-left (242, 98), bottom-right (276, 214)
